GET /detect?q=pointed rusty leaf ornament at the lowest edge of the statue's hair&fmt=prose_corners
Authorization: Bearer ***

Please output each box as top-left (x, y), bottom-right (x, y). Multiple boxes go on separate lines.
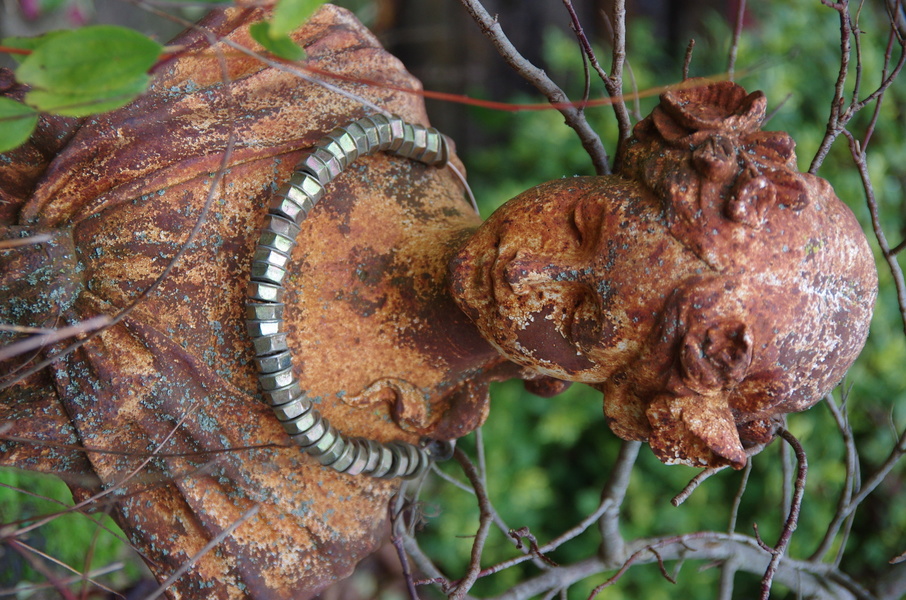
top-left (646, 393), bottom-right (747, 469)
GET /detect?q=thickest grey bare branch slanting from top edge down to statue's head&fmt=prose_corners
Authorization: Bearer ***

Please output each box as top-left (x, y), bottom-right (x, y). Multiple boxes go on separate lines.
top-left (460, 0), bottom-right (610, 175)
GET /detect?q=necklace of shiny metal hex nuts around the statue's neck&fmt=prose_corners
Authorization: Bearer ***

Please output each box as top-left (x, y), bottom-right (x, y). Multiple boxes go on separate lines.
top-left (246, 115), bottom-right (450, 479)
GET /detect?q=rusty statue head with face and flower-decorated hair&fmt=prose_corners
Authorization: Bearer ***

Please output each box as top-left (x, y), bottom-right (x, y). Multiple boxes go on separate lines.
top-left (451, 82), bottom-right (877, 468)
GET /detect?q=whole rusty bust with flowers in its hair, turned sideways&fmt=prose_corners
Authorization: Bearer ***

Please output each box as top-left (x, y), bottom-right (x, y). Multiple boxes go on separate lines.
top-left (0, 6), bottom-right (876, 598)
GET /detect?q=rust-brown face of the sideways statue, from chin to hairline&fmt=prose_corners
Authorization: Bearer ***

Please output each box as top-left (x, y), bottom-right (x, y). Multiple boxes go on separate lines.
top-left (451, 177), bottom-right (706, 383)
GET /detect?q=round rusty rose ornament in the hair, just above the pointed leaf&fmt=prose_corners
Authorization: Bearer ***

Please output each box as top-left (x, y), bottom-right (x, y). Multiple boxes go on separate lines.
top-left (679, 320), bottom-right (753, 394)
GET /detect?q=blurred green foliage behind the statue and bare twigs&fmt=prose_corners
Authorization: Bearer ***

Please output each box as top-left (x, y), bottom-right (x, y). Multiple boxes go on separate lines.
top-left (0, 0), bottom-right (906, 600)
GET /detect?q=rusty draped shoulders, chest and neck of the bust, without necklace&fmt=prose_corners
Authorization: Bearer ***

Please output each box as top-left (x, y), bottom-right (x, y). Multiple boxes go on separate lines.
top-left (0, 6), bottom-right (502, 599)
